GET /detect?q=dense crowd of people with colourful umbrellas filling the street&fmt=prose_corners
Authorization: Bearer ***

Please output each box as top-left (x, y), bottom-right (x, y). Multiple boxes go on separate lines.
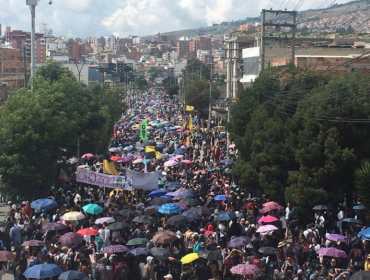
top-left (0, 88), bottom-right (370, 280)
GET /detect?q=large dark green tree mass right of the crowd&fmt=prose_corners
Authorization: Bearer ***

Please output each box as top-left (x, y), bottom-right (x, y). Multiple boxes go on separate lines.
top-left (228, 67), bottom-right (370, 217)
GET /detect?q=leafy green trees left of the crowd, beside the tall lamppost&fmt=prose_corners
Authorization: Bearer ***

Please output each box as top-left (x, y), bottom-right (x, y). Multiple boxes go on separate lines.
top-left (0, 62), bottom-right (122, 199)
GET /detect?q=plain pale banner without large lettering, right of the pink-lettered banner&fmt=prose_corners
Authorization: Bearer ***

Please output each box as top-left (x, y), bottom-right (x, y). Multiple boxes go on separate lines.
top-left (126, 170), bottom-right (161, 191)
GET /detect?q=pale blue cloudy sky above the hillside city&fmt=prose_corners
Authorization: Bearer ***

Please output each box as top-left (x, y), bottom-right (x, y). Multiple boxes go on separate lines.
top-left (0, 0), bottom-right (348, 38)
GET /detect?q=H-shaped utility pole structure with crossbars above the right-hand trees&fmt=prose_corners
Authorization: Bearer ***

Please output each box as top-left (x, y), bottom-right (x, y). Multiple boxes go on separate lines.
top-left (260, 9), bottom-right (297, 71)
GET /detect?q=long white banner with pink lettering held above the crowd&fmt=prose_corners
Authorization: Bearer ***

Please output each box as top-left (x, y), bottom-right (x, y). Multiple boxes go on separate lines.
top-left (76, 167), bottom-right (132, 191)
